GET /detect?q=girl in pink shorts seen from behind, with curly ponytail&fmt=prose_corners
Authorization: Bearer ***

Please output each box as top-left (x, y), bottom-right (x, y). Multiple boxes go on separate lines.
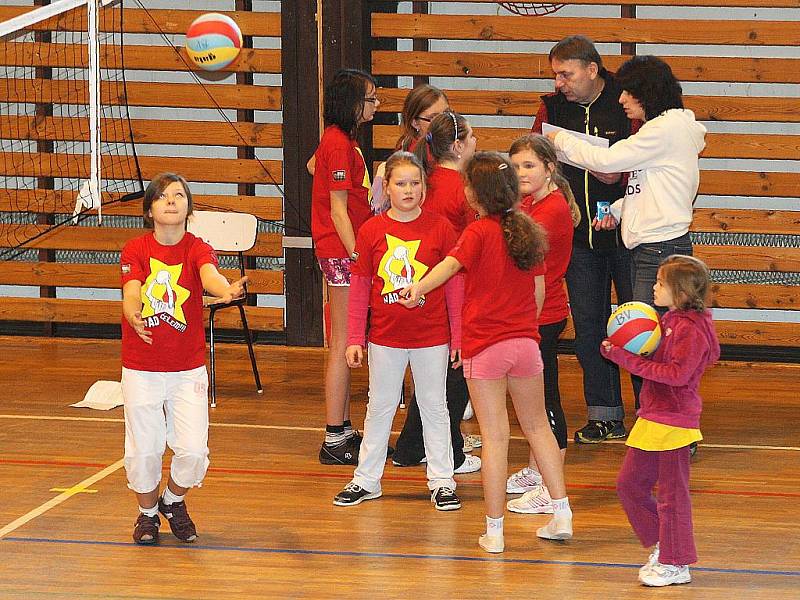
top-left (401, 152), bottom-right (572, 552)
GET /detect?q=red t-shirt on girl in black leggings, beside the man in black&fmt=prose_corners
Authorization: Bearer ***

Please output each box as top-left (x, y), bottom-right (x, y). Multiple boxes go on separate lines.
top-left (521, 190), bottom-right (575, 325)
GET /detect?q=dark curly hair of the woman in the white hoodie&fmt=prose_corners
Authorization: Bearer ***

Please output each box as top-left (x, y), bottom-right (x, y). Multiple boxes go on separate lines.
top-left (616, 55), bottom-right (683, 121)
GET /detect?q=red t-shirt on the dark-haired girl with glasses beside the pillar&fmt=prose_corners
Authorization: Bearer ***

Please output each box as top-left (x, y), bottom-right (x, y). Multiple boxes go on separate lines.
top-left (311, 125), bottom-right (372, 258)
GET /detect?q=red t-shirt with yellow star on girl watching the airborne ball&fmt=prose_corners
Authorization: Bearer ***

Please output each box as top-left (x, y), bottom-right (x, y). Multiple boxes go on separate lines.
top-left (120, 232), bottom-right (217, 372)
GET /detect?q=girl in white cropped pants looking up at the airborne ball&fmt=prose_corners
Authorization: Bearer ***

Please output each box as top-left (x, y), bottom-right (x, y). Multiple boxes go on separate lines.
top-left (120, 173), bottom-right (247, 545)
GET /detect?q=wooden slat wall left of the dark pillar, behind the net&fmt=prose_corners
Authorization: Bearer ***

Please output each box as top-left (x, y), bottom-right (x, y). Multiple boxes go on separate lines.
top-left (0, 7), bottom-right (284, 332)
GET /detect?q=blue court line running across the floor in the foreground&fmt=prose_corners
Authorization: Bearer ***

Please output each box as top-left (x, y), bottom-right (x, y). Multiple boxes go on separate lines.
top-left (3, 537), bottom-right (800, 577)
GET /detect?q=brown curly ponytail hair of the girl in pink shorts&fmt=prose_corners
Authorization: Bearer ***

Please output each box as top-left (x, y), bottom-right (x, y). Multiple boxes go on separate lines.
top-left (464, 152), bottom-right (547, 271)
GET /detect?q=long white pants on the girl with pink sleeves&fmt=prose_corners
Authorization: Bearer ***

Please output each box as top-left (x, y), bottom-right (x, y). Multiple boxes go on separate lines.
top-left (353, 343), bottom-right (456, 492)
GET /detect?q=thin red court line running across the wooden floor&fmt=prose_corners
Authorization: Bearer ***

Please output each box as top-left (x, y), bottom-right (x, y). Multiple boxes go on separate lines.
top-left (6, 458), bottom-right (800, 498)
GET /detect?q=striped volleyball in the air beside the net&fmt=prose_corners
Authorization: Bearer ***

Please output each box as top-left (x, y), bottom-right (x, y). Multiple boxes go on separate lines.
top-left (186, 13), bottom-right (244, 71)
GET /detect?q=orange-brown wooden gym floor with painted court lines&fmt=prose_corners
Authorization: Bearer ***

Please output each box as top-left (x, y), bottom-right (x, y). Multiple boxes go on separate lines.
top-left (0, 337), bottom-right (800, 599)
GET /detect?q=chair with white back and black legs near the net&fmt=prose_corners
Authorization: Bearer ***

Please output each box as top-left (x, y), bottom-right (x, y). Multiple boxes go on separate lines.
top-left (186, 210), bottom-right (264, 408)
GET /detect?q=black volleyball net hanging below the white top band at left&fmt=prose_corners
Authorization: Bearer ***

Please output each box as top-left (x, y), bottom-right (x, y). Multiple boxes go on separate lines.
top-left (0, 6), bottom-right (142, 260)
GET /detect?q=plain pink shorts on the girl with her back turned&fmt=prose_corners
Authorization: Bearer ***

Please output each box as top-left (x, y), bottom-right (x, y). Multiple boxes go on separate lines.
top-left (464, 338), bottom-right (544, 379)
